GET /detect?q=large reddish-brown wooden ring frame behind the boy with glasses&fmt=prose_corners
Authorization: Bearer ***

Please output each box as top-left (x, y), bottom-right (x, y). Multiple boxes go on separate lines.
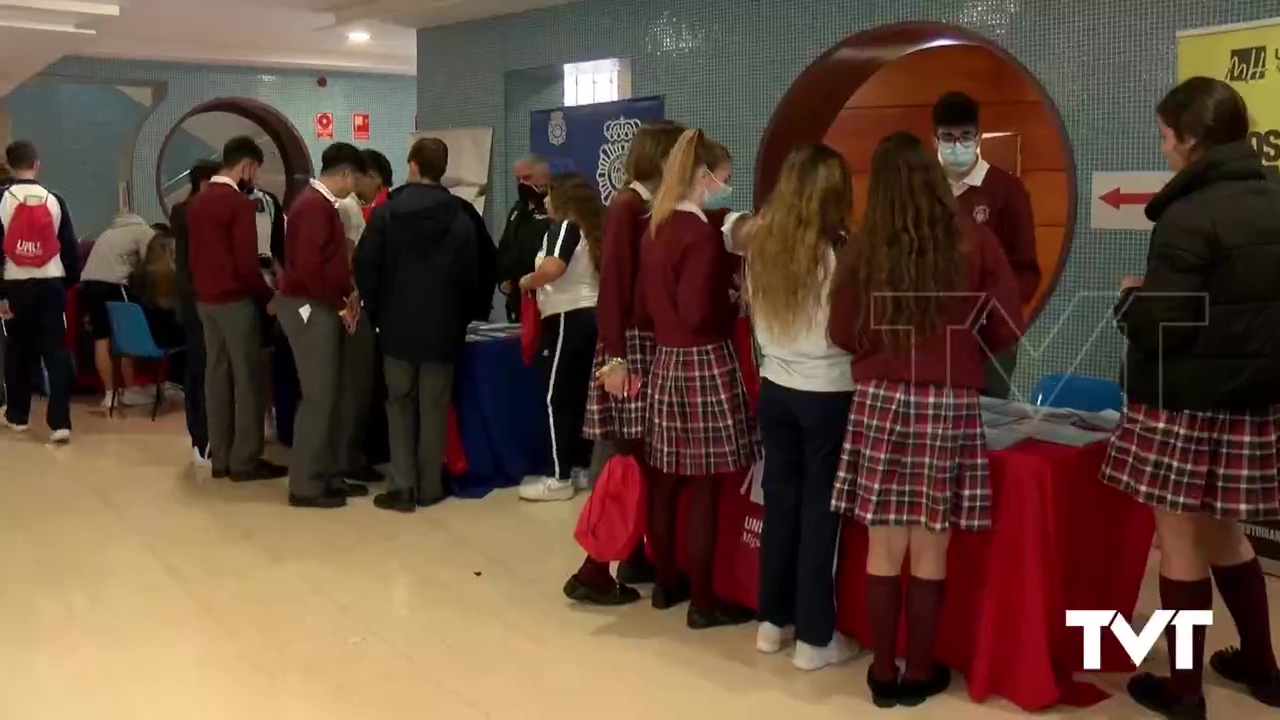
top-left (754, 22), bottom-right (1078, 322)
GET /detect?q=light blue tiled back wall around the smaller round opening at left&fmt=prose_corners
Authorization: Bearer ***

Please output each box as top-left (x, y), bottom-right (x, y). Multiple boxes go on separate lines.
top-left (5, 58), bottom-right (416, 234)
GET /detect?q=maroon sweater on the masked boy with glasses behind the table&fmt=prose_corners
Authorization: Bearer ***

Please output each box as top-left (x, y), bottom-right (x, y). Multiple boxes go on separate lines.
top-left (956, 165), bottom-right (1041, 302)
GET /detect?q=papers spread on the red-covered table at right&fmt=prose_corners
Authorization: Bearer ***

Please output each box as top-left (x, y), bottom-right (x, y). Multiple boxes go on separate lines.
top-left (982, 397), bottom-right (1120, 450)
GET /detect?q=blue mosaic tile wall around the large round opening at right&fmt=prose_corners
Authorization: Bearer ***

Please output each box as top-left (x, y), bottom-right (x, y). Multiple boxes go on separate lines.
top-left (417, 0), bottom-right (1280, 389)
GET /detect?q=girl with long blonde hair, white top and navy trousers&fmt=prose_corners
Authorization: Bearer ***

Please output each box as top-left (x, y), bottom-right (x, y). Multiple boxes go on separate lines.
top-left (739, 145), bottom-right (855, 670)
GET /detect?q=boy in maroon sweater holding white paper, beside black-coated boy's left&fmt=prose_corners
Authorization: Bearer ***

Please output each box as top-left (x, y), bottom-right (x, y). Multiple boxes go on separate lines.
top-left (275, 142), bottom-right (369, 509)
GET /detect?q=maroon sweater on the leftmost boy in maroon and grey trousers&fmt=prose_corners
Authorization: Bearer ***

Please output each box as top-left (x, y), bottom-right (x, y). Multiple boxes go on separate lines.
top-left (187, 182), bottom-right (271, 305)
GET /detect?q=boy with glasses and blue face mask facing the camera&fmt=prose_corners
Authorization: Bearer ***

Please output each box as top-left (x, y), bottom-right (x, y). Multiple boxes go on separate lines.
top-left (933, 91), bottom-right (1041, 398)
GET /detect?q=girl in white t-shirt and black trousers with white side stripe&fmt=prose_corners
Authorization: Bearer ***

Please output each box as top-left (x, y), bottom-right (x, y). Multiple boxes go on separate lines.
top-left (520, 174), bottom-right (604, 501)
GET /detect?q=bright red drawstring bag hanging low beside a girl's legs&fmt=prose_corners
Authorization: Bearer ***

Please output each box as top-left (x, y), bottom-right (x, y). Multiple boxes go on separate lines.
top-left (573, 455), bottom-right (649, 562)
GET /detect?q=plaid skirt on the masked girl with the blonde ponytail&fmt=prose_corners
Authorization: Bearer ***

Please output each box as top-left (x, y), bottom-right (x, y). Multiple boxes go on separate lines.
top-left (645, 342), bottom-right (760, 475)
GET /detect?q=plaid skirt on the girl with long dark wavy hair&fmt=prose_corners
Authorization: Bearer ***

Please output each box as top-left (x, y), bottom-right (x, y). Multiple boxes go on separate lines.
top-left (831, 380), bottom-right (992, 532)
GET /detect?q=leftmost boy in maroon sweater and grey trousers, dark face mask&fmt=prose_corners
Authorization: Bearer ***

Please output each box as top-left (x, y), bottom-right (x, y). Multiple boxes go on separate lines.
top-left (187, 136), bottom-right (288, 482)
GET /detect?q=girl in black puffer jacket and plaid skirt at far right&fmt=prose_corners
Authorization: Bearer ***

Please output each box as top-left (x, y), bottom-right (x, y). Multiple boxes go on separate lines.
top-left (1102, 77), bottom-right (1280, 720)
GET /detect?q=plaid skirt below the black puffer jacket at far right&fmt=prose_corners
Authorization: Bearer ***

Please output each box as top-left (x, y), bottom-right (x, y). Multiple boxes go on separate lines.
top-left (1101, 402), bottom-right (1280, 520)
